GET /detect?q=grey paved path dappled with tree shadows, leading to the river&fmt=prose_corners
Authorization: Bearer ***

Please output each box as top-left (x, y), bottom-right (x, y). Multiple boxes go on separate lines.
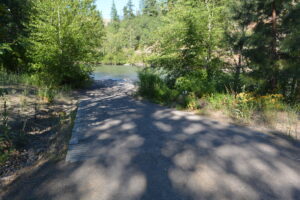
top-left (3, 80), bottom-right (300, 200)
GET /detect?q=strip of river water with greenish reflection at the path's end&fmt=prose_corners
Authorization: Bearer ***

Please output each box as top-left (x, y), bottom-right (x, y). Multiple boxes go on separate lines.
top-left (92, 65), bottom-right (141, 81)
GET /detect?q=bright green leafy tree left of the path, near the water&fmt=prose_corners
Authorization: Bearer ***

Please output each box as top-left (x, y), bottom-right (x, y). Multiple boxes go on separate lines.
top-left (26, 0), bottom-right (104, 87)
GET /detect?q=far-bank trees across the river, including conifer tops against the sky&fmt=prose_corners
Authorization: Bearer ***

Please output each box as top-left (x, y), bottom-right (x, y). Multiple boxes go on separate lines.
top-left (101, 0), bottom-right (163, 65)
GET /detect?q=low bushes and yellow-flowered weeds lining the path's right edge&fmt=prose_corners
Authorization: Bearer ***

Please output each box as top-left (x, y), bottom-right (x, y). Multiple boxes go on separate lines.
top-left (139, 68), bottom-right (300, 135)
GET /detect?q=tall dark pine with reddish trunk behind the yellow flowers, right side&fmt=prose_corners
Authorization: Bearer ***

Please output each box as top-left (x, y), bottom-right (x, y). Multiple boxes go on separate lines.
top-left (247, 0), bottom-right (293, 92)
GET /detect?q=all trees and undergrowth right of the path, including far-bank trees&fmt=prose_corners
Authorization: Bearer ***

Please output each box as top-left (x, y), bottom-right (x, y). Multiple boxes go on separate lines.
top-left (108, 0), bottom-right (300, 137)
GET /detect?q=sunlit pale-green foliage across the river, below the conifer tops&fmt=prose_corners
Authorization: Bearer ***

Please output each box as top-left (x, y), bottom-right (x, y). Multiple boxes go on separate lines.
top-left (102, 15), bottom-right (160, 64)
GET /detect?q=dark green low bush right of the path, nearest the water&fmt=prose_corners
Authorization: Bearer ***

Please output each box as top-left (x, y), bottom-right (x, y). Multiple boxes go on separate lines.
top-left (139, 68), bottom-right (232, 109)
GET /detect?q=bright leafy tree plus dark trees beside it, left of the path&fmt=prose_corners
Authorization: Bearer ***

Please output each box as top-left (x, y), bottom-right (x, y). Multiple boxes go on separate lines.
top-left (0, 0), bottom-right (104, 87)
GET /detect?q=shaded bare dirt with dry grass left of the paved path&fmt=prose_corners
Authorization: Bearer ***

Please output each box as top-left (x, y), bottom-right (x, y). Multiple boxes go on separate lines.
top-left (0, 82), bottom-right (76, 181)
